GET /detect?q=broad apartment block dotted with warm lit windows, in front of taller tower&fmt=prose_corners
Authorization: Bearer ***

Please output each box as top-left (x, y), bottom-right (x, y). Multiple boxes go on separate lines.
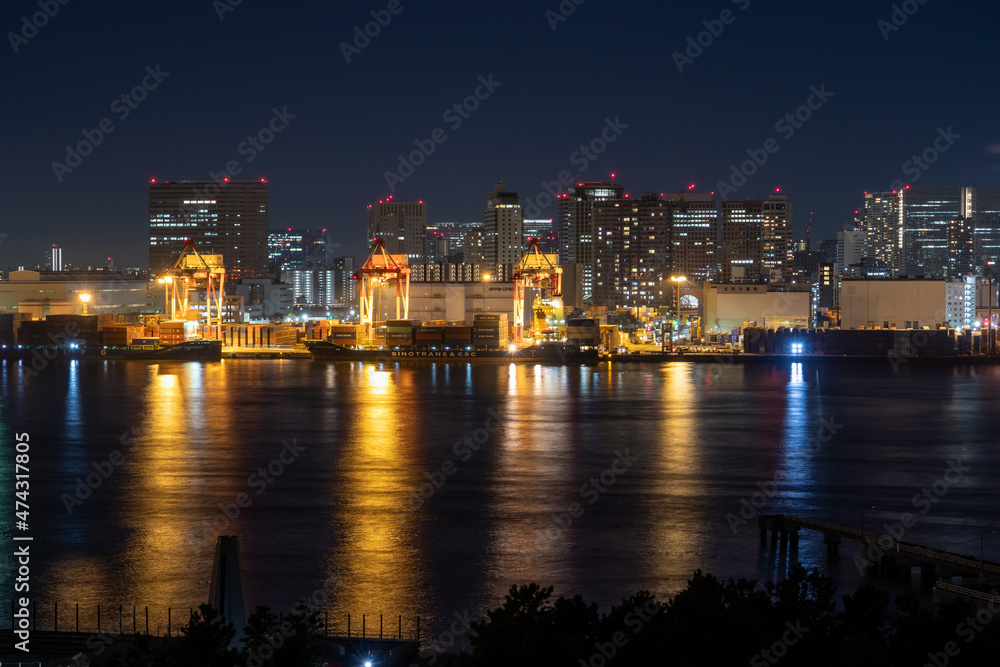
top-left (592, 193), bottom-right (676, 307)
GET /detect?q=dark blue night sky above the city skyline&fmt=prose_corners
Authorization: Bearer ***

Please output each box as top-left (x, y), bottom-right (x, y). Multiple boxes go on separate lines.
top-left (0, 0), bottom-right (1000, 266)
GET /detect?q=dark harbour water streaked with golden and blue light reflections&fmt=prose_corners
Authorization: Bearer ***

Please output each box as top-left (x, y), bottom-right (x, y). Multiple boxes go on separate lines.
top-left (0, 360), bottom-right (1000, 635)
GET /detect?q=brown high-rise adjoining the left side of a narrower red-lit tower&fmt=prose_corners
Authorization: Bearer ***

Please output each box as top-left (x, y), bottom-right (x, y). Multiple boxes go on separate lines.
top-left (720, 197), bottom-right (764, 284)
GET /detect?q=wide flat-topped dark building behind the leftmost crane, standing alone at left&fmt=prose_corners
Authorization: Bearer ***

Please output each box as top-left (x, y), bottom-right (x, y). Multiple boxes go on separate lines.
top-left (149, 180), bottom-right (268, 280)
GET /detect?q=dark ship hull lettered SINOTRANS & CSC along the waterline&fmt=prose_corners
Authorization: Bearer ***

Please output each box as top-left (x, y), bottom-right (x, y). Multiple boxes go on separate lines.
top-left (305, 341), bottom-right (600, 364)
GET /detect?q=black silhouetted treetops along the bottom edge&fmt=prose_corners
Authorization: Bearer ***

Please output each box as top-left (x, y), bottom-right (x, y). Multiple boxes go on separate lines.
top-left (103, 568), bottom-right (1000, 667)
